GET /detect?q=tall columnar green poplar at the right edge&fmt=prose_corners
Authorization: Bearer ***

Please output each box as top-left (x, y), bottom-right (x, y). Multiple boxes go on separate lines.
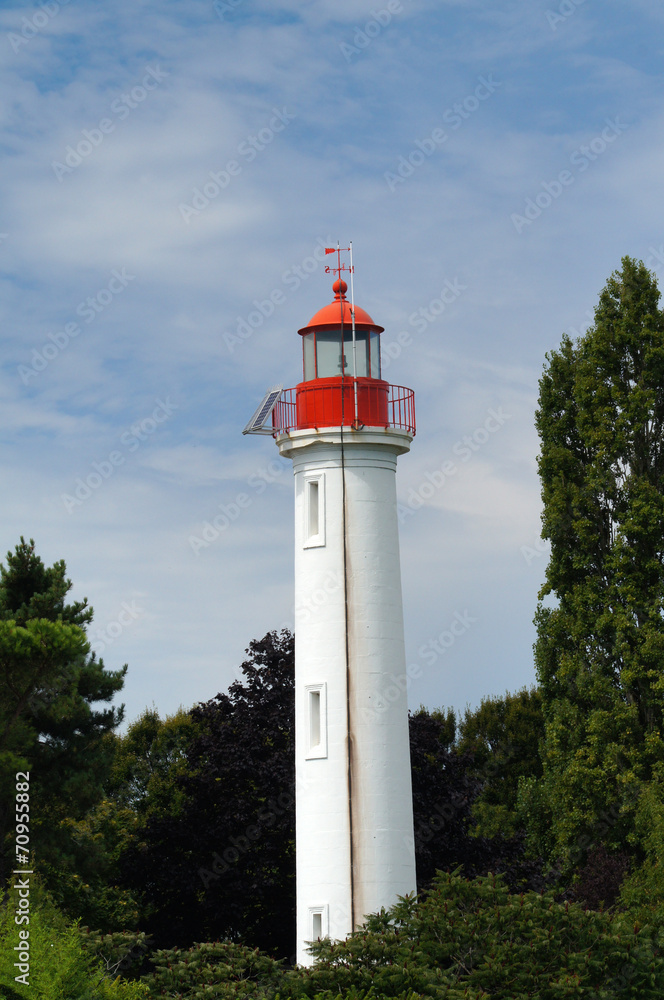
top-left (521, 257), bottom-right (664, 863)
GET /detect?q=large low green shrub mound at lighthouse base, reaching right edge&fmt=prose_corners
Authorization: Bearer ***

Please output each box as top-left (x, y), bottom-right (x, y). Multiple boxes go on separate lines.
top-left (288, 873), bottom-right (664, 1000)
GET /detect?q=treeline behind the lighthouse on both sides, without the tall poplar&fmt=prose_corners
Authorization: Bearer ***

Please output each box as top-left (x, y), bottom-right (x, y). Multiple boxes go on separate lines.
top-left (0, 540), bottom-right (544, 959)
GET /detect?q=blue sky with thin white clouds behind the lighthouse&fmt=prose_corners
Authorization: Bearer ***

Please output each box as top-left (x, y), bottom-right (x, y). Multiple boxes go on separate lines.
top-left (0, 0), bottom-right (664, 736)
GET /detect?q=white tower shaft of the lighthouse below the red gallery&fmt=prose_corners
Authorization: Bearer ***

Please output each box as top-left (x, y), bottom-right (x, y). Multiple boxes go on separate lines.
top-left (277, 428), bottom-right (415, 964)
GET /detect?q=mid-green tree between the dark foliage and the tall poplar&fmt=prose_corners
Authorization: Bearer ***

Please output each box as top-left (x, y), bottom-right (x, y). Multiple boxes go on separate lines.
top-left (457, 687), bottom-right (544, 837)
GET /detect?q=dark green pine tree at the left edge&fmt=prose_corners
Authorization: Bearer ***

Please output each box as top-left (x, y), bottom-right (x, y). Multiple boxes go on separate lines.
top-left (0, 538), bottom-right (127, 888)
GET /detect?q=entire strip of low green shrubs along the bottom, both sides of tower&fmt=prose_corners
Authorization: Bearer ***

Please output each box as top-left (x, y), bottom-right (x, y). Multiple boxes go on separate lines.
top-left (135, 872), bottom-right (664, 1000)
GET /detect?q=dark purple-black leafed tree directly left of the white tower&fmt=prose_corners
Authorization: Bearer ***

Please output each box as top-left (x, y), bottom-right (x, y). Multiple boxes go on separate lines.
top-left (123, 630), bottom-right (295, 957)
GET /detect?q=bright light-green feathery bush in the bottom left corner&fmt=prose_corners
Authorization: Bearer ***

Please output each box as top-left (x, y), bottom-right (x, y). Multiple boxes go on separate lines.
top-left (0, 875), bottom-right (147, 1000)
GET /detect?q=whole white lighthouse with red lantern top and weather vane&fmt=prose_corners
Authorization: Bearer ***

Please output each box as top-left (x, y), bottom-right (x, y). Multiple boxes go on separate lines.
top-left (245, 251), bottom-right (416, 965)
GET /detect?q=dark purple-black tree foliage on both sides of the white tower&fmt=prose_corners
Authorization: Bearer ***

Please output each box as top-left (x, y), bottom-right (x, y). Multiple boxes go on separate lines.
top-left (116, 644), bottom-right (548, 958)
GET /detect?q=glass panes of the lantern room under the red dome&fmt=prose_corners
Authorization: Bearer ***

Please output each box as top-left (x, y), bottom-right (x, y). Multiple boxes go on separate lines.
top-left (302, 327), bottom-right (380, 382)
